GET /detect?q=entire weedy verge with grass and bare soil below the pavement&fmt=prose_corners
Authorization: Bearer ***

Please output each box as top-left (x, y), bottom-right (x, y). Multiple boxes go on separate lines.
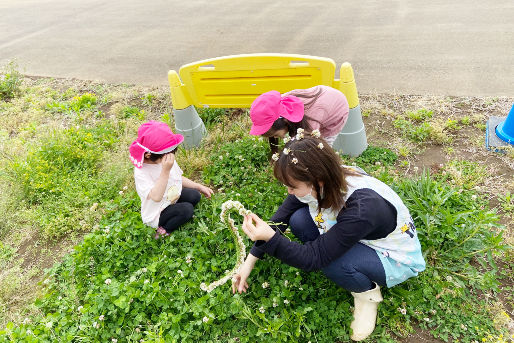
top-left (0, 74), bottom-right (514, 342)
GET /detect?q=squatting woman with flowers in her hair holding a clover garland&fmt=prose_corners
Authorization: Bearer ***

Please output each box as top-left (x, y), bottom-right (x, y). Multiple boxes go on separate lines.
top-left (232, 131), bottom-right (425, 341)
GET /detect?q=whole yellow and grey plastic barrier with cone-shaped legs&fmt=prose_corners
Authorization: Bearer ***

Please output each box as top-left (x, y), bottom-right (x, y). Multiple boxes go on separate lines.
top-left (168, 54), bottom-right (367, 156)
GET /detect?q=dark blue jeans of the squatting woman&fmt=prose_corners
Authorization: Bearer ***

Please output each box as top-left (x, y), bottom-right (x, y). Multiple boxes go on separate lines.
top-left (289, 207), bottom-right (386, 293)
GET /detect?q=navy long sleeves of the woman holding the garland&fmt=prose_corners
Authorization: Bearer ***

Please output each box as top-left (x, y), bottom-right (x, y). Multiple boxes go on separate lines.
top-left (250, 188), bottom-right (397, 271)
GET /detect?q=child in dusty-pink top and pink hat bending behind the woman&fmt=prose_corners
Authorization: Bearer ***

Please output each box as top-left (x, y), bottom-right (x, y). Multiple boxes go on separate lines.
top-left (250, 85), bottom-right (350, 152)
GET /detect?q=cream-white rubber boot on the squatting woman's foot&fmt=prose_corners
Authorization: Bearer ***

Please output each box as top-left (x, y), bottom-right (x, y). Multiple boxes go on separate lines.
top-left (350, 284), bottom-right (384, 341)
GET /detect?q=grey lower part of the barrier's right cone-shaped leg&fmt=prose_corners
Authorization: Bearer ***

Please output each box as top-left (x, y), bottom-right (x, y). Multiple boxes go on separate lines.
top-left (333, 105), bottom-right (368, 157)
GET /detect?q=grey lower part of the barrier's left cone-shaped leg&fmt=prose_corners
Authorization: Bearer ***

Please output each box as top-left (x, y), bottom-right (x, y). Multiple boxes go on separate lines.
top-left (173, 105), bottom-right (207, 148)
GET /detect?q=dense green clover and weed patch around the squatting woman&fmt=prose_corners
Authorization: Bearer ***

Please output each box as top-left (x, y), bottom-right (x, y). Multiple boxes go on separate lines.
top-left (0, 137), bottom-right (504, 342)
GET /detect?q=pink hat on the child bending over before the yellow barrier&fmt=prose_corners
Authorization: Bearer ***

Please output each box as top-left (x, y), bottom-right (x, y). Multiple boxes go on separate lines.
top-left (250, 91), bottom-right (303, 136)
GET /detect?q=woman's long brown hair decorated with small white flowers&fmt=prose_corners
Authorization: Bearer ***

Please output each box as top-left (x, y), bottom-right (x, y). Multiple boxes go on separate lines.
top-left (273, 134), bottom-right (359, 211)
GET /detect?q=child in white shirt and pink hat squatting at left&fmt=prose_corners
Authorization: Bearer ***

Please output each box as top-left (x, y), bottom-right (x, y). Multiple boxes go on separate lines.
top-left (129, 121), bottom-right (213, 238)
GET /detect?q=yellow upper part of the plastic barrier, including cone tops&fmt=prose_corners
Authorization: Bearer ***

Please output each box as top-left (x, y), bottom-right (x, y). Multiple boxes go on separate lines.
top-left (168, 54), bottom-right (359, 109)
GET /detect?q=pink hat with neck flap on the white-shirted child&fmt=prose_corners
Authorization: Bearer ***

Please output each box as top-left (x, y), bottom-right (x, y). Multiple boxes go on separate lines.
top-left (129, 120), bottom-right (184, 168)
